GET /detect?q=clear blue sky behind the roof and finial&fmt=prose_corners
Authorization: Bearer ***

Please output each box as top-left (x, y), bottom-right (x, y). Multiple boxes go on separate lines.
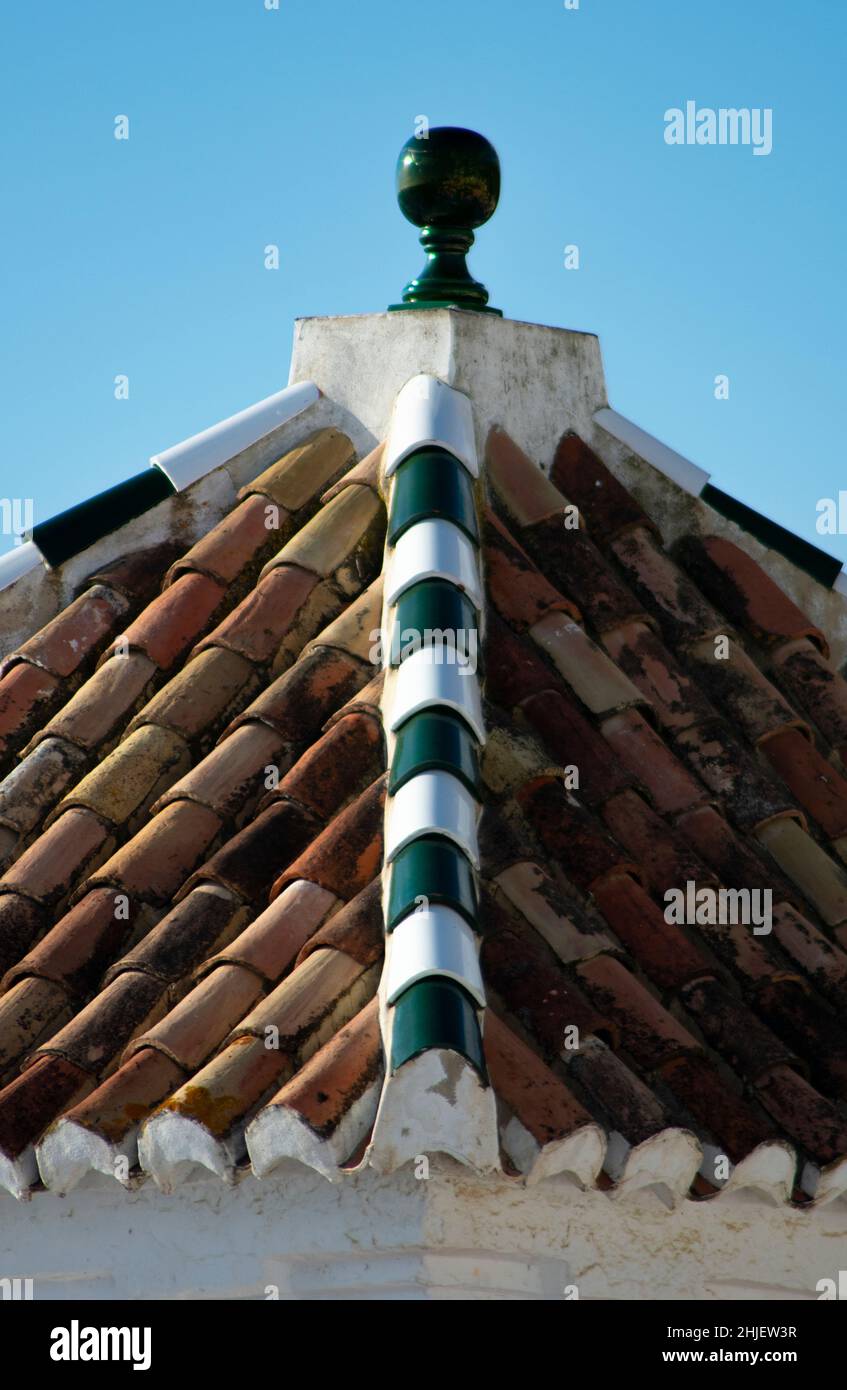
top-left (0, 0), bottom-right (847, 559)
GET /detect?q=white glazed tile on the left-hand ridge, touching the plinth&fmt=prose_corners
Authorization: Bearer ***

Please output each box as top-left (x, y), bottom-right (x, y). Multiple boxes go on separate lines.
top-left (150, 381), bottom-right (320, 492)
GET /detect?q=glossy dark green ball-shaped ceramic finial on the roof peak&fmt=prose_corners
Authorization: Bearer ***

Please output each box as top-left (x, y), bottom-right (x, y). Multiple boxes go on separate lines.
top-left (389, 125), bottom-right (502, 317)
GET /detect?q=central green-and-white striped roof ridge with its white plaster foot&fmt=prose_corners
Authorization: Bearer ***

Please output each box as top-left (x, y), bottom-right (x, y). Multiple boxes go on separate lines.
top-left (369, 375), bottom-right (501, 1172)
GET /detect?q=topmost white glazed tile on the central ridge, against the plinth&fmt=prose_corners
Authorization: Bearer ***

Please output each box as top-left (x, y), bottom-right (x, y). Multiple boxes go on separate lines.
top-left (384, 374), bottom-right (480, 478)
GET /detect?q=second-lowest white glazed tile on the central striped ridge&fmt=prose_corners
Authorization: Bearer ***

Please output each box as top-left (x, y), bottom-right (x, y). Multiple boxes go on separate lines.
top-left (385, 771), bottom-right (480, 869)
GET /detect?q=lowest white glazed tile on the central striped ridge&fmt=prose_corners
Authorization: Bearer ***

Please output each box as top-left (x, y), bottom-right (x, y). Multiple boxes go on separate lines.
top-left (385, 905), bottom-right (485, 1009)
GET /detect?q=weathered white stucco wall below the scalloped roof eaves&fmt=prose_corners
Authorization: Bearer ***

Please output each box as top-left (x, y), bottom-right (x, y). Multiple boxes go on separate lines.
top-left (0, 1159), bottom-right (847, 1301)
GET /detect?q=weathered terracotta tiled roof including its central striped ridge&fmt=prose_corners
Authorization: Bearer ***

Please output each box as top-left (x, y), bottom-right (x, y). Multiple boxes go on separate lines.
top-left (0, 378), bottom-right (847, 1202)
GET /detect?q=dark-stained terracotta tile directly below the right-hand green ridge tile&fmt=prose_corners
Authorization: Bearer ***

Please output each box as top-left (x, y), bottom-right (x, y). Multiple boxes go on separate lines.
top-left (677, 535), bottom-right (829, 656)
